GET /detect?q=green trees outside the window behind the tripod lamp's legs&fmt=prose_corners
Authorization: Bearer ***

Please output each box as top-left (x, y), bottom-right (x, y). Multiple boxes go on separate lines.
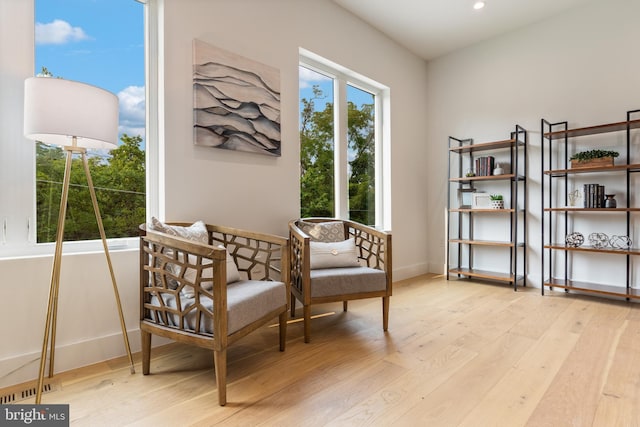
top-left (36, 134), bottom-right (145, 242)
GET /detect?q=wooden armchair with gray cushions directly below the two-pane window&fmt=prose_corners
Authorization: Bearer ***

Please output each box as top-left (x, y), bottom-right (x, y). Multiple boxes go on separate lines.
top-left (289, 218), bottom-right (392, 342)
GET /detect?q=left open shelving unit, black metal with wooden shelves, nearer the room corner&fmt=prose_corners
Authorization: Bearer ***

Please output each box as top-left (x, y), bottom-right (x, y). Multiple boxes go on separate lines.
top-left (446, 125), bottom-right (528, 290)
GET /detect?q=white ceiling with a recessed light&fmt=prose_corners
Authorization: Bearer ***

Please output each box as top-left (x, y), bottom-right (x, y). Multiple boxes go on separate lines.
top-left (333, 0), bottom-right (595, 60)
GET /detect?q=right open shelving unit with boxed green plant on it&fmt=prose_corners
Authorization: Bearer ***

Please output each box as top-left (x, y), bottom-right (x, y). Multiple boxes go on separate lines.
top-left (541, 110), bottom-right (640, 300)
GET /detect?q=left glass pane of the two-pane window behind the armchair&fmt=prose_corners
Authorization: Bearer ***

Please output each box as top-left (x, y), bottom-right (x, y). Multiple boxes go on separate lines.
top-left (299, 66), bottom-right (335, 221)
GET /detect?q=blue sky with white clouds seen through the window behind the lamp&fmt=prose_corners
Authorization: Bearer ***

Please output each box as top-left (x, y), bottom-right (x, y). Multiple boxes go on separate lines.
top-left (34, 0), bottom-right (145, 142)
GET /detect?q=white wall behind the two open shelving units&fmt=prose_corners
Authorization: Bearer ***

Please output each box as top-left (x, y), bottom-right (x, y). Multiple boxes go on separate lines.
top-left (426, 0), bottom-right (640, 286)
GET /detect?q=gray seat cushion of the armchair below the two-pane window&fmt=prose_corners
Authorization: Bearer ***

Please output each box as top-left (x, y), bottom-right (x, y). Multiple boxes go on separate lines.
top-left (310, 267), bottom-right (387, 298)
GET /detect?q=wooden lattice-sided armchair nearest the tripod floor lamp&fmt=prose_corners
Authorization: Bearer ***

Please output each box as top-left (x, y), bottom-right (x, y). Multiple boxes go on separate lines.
top-left (140, 222), bottom-right (290, 405)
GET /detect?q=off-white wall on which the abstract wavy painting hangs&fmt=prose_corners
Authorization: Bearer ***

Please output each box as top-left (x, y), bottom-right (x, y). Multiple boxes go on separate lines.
top-left (0, 0), bottom-right (430, 387)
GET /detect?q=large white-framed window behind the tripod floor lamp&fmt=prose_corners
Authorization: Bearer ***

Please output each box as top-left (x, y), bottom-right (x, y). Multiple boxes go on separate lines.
top-left (0, 0), bottom-right (151, 258)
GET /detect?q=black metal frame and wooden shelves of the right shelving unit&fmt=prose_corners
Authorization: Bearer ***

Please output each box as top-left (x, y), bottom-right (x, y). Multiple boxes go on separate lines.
top-left (540, 110), bottom-right (640, 301)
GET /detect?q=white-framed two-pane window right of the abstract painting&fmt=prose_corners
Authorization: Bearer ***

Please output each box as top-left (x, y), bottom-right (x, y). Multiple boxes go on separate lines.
top-left (299, 50), bottom-right (389, 226)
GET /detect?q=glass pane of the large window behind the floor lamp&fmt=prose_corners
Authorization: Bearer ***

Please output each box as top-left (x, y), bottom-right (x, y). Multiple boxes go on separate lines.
top-left (35, 0), bottom-right (146, 243)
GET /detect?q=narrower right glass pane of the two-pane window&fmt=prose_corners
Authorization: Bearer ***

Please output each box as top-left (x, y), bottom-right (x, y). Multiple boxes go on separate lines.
top-left (347, 85), bottom-right (376, 225)
